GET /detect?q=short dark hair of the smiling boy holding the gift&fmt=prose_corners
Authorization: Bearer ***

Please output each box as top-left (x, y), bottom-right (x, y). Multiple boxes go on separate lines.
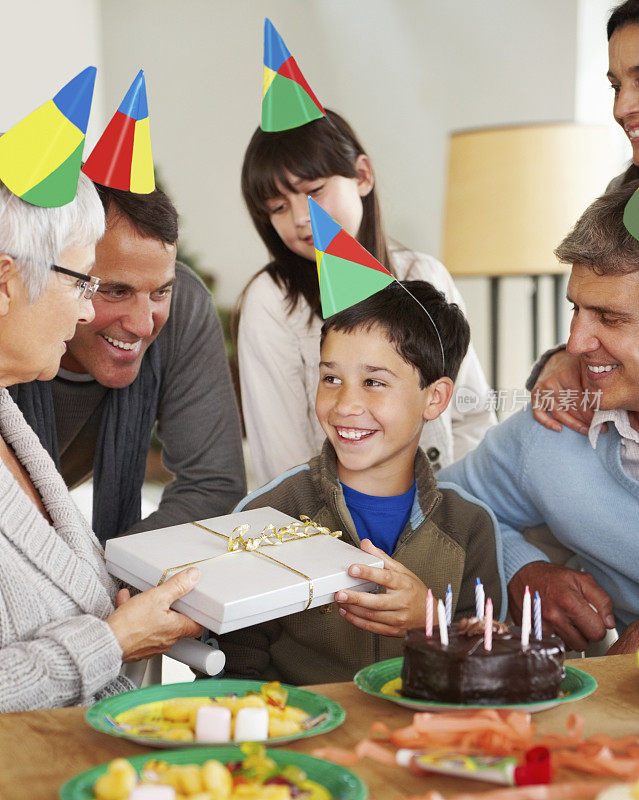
top-left (320, 281), bottom-right (470, 389)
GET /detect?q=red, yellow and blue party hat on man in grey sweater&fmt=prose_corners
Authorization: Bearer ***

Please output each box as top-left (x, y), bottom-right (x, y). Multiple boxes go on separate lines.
top-left (82, 70), bottom-right (155, 194)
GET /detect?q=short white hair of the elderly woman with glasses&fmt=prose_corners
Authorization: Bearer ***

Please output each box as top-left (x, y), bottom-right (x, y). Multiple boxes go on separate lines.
top-left (0, 172), bottom-right (105, 303)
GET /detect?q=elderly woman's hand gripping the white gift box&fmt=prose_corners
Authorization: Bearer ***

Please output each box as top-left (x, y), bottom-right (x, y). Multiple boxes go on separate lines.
top-left (106, 567), bottom-right (204, 662)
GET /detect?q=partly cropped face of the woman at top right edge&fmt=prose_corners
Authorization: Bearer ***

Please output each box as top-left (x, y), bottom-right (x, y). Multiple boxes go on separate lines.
top-left (608, 23), bottom-right (639, 166)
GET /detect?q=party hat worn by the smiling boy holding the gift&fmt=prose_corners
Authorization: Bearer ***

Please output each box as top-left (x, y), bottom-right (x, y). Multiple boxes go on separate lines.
top-left (308, 197), bottom-right (395, 319)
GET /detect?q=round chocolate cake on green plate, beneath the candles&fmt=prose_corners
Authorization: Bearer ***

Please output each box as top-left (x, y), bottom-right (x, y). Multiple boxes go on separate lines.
top-left (402, 618), bottom-right (565, 705)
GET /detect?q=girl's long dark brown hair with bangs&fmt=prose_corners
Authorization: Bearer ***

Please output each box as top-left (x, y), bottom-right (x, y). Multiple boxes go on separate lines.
top-left (238, 109), bottom-right (392, 321)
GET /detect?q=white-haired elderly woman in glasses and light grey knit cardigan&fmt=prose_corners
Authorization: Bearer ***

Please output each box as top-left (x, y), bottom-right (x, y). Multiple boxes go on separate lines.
top-left (0, 174), bottom-right (201, 711)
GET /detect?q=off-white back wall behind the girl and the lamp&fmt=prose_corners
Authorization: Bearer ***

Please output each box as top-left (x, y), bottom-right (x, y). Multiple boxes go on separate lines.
top-left (101, 0), bottom-right (632, 396)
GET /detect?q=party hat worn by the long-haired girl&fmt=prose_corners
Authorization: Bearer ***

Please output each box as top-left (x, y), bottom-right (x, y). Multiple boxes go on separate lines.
top-left (262, 19), bottom-right (324, 133)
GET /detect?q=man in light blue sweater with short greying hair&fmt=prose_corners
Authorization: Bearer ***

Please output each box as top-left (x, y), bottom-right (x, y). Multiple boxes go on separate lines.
top-left (438, 182), bottom-right (639, 652)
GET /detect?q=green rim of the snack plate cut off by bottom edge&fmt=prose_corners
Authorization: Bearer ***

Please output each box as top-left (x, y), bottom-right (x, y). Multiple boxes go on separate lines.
top-left (59, 748), bottom-right (368, 800)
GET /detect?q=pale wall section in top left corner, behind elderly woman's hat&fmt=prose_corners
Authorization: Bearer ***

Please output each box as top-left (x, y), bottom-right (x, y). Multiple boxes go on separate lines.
top-left (0, 0), bottom-right (104, 153)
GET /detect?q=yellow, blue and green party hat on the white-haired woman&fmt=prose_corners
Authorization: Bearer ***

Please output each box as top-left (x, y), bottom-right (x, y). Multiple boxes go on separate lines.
top-left (0, 67), bottom-right (97, 208)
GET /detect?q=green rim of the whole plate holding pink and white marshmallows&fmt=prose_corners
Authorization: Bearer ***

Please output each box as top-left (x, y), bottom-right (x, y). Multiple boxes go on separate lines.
top-left (85, 678), bottom-right (346, 750)
